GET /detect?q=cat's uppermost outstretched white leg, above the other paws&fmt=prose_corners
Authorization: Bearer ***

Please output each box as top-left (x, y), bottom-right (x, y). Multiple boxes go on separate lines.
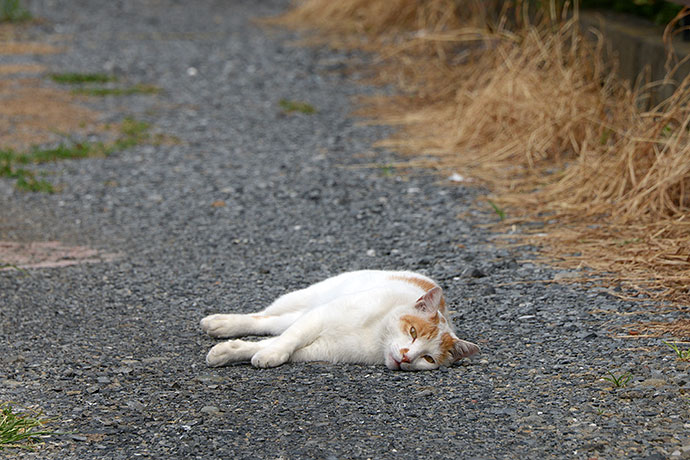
top-left (196, 312), bottom-right (302, 338)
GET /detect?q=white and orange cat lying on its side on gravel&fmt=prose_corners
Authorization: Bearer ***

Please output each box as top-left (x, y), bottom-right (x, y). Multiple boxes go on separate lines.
top-left (201, 270), bottom-right (479, 371)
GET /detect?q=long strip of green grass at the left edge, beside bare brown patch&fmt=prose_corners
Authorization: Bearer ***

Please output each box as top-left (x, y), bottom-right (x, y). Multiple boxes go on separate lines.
top-left (0, 118), bottom-right (159, 193)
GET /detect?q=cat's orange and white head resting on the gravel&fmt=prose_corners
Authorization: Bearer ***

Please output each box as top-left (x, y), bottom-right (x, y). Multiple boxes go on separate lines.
top-left (384, 287), bottom-right (479, 371)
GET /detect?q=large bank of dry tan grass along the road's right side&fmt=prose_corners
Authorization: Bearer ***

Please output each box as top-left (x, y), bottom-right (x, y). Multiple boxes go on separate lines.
top-left (277, 0), bottom-right (690, 335)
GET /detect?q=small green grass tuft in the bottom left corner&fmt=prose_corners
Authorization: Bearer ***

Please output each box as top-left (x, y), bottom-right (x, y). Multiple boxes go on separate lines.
top-left (0, 403), bottom-right (55, 451)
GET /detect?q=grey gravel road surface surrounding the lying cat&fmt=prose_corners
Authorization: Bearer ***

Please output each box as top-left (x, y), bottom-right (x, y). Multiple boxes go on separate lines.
top-left (0, 0), bottom-right (690, 460)
